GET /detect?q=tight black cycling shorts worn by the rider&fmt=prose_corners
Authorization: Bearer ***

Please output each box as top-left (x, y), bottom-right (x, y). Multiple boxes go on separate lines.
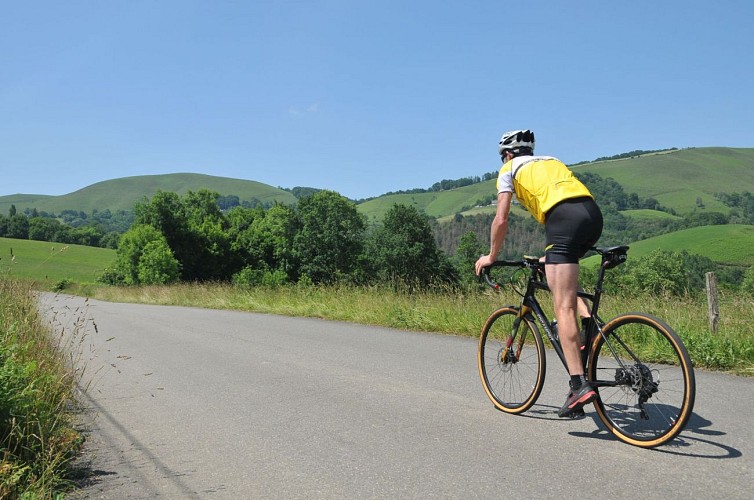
top-left (545, 197), bottom-right (602, 264)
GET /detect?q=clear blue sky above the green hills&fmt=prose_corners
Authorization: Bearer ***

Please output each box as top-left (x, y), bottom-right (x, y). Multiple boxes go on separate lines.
top-left (0, 0), bottom-right (754, 199)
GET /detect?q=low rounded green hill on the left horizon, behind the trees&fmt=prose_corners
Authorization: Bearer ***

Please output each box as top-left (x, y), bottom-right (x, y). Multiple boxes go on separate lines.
top-left (0, 174), bottom-right (296, 215)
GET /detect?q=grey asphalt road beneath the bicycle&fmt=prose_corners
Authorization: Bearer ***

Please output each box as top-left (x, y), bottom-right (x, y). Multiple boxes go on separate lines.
top-left (40, 294), bottom-right (754, 499)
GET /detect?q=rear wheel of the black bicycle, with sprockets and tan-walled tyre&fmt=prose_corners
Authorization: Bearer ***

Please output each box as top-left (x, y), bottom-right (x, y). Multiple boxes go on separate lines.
top-left (588, 313), bottom-right (696, 448)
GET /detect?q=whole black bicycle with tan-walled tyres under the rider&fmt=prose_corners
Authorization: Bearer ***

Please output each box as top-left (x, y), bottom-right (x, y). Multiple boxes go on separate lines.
top-left (478, 246), bottom-right (696, 448)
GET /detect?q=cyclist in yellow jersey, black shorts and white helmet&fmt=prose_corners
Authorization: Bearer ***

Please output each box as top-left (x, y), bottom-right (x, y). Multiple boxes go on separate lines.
top-left (475, 130), bottom-right (602, 417)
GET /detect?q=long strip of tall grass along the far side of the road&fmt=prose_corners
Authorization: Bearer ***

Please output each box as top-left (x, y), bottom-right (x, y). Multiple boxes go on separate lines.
top-left (88, 284), bottom-right (754, 376)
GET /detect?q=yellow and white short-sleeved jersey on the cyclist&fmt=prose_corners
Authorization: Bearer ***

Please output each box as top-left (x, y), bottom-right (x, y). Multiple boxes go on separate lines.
top-left (497, 156), bottom-right (594, 224)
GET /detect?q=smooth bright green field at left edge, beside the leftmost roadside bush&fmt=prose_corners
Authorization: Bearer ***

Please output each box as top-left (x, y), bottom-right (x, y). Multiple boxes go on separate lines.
top-left (0, 238), bottom-right (115, 286)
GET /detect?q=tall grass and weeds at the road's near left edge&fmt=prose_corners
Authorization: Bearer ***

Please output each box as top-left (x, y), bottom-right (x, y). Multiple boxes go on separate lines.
top-left (0, 278), bottom-right (82, 498)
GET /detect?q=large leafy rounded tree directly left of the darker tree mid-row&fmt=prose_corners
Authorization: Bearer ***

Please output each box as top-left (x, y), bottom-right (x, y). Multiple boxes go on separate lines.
top-left (293, 191), bottom-right (366, 283)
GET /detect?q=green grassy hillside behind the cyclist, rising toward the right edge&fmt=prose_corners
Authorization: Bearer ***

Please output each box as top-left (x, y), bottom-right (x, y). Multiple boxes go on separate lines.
top-left (359, 148), bottom-right (754, 220)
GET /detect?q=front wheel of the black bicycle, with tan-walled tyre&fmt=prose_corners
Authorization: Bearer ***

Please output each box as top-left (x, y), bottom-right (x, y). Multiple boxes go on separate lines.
top-left (478, 306), bottom-right (546, 414)
